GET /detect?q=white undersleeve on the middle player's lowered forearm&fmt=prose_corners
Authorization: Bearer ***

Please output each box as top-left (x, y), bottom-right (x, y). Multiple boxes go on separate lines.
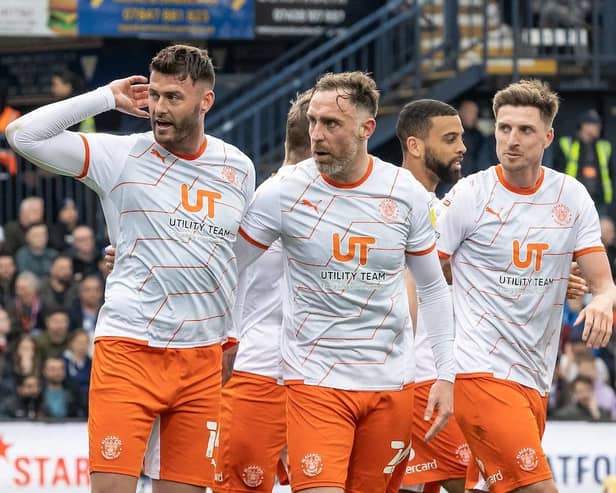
top-left (407, 250), bottom-right (455, 382)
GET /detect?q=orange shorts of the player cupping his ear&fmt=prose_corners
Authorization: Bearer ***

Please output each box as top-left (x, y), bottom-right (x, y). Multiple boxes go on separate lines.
top-left (88, 338), bottom-right (222, 486)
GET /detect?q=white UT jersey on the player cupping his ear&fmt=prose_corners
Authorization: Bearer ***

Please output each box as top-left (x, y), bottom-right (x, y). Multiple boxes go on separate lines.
top-left (83, 132), bottom-right (254, 348)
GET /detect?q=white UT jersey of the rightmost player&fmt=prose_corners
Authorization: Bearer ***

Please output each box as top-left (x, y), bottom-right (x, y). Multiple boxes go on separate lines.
top-left (438, 166), bottom-right (603, 394)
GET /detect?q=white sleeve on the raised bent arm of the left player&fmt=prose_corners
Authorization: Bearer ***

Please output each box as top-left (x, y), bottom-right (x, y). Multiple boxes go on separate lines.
top-left (6, 87), bottom-right (115, 176)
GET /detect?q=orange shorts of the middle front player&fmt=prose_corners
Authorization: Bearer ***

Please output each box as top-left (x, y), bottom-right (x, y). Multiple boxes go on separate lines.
top-left (287, 383), bottom-right (413, 493)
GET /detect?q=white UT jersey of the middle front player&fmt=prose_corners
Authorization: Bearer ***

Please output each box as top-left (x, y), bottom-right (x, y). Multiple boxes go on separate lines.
top-left (240, 158), bottom-right (435, 390)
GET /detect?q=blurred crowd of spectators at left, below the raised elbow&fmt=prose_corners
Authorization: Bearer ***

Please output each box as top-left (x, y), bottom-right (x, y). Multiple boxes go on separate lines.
top-left (0, 197), bottom-right (106, 419)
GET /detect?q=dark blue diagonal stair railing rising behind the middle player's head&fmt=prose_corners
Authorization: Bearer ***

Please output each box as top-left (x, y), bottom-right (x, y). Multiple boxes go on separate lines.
top-left (206, 1), bottom-right (445, 179)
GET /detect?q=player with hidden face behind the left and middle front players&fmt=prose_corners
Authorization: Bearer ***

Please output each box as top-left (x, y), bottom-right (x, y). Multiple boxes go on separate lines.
top-left (214, 92), bottom-right (310, 493)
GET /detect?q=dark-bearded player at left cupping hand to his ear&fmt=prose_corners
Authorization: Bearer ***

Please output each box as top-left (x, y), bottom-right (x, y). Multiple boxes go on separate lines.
top-left (7, 45), bottom-right (254, 493)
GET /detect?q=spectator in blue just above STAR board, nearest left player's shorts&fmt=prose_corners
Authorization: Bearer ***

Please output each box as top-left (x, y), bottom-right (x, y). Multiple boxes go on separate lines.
top-left (42, 358), bottom-right (87, 418)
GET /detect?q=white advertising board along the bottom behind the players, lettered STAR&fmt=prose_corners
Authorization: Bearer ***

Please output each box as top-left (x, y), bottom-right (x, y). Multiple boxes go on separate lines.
top-left (0, 421), bottom-right (616, 493)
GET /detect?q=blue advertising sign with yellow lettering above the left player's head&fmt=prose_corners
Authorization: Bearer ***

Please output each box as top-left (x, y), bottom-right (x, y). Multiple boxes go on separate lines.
top-left (77, 0), bottom-right (254, 39)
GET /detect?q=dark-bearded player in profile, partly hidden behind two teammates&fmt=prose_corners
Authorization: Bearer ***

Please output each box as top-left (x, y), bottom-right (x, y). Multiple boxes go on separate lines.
top-left (396, 99), bottom-right (470, 493)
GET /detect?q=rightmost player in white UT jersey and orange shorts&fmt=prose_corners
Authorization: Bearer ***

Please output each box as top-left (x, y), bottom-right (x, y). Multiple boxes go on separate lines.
top-left (438, 81), bottom-right (616, 493)
